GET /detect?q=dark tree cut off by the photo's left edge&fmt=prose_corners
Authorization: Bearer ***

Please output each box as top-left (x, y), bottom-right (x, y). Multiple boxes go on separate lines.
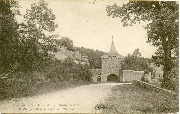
top-left (0, 0), bottom-right (20, 74)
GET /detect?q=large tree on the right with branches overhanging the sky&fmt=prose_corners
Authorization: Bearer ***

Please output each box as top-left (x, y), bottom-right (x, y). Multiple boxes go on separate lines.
top-left (106, 0), bottom-right (179, 89)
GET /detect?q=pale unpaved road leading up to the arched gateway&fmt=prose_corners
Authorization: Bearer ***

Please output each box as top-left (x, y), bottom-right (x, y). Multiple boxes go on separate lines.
top-left (0, 83), bottom-right (131, 113)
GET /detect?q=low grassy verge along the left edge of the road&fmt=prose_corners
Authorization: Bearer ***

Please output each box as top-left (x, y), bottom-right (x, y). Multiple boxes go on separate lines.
top-left (0, 75), bottom-right (89, 101)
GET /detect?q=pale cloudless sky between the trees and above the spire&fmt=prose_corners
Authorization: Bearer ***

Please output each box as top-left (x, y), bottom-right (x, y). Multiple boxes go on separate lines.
top-left (18, 0), bottom-right (156, 58)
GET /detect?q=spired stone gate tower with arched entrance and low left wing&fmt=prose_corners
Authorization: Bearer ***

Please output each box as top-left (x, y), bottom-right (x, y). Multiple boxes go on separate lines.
top-left (91, 39), bottom-right (124, 82)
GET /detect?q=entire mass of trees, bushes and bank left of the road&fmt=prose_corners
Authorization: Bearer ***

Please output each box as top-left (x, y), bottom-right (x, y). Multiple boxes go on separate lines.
top-left (0, 0), bottom-right (91, 100)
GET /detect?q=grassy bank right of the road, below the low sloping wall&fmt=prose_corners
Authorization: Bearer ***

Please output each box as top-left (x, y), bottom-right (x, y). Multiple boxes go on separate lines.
top-left (97, 85), bottom-right (179, 113)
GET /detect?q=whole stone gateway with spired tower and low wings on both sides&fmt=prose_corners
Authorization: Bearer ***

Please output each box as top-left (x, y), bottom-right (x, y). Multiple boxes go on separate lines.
top-left (91, 39), bottom-right (144, 82)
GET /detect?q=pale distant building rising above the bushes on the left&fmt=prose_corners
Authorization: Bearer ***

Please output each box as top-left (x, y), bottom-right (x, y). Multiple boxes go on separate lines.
top-left (51, 47), bottom-right (89, 65)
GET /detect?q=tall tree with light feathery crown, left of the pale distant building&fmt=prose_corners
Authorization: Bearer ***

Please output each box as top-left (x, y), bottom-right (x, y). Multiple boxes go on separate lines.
top-left (19, 0), bottom-right (58, 71)
